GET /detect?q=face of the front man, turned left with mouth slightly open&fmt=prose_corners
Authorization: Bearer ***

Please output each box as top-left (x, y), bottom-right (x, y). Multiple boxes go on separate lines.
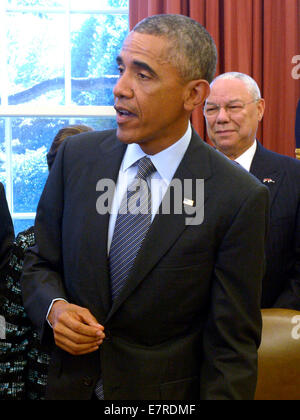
top-left (114, 32), bottom-right (189, 154)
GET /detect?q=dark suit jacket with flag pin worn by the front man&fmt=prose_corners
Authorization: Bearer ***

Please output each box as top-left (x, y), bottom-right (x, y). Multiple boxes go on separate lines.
top-left (22, 131), bottom-right (269, 400)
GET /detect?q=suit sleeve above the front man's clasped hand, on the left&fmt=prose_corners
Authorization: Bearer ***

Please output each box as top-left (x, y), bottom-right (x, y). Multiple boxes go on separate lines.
top-left (21, 142), bottom-right (67, 338)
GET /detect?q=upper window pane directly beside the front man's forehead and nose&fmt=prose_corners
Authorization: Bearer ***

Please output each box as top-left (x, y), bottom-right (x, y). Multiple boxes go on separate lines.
top-left (71, 14), bottom-right (128, 105)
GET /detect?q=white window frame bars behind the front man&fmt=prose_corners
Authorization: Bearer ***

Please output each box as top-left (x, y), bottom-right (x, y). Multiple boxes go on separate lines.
top-left (0, 0), bottom-right (129, 220)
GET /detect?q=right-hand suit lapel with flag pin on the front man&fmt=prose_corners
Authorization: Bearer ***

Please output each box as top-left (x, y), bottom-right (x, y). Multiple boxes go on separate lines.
top-left (107, 133), bottom-right (211, 320)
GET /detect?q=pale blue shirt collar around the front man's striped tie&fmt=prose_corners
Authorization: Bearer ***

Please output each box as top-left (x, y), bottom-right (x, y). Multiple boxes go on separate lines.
top-left (121, 122), bottom-right (192, 183)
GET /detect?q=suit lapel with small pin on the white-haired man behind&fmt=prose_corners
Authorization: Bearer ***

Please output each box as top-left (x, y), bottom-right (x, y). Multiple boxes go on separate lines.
top-left (250, 142), bottom-right (285, 207)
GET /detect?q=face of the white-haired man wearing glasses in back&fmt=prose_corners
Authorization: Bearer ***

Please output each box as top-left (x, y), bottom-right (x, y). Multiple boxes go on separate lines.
top-left (205, 79), bottom-right (264, 159)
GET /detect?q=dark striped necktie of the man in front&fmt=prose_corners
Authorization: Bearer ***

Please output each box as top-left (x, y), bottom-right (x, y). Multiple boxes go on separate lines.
top-left (95, 157), bottom-right (156, 400)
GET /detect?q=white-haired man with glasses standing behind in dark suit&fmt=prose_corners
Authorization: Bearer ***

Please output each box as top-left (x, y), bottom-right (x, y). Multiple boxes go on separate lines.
top-left (204, 72), bottom-right (300, 310)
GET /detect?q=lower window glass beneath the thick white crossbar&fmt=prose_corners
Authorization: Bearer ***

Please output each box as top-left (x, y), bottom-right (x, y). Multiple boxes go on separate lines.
top-left (0, 117), bottom-right (116, 217)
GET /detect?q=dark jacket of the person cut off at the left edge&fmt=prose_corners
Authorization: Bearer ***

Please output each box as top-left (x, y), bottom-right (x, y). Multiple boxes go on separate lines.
top-left (0, 183), bottom-right (15, 270)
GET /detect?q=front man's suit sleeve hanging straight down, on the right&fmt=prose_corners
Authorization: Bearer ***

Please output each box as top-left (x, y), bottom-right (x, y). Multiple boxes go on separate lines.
top-left (200, 186), bottom-right (269, 400)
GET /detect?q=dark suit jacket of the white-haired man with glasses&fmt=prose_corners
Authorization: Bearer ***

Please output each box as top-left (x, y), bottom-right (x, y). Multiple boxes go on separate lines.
top-left (250, 143), bottom-right (300, 310)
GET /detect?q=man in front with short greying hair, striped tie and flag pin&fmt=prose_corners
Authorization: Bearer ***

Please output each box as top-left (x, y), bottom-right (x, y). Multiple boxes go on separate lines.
top-left (22, 15), bottom-right (269, 400)
